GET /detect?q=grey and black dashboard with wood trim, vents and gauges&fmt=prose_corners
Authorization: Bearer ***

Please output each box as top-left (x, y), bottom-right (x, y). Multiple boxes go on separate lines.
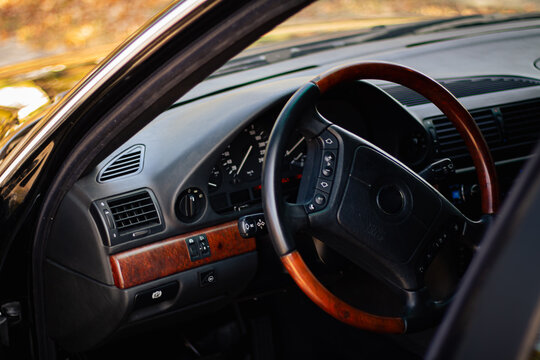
top-left (45, 22), bottom-right (540, 351)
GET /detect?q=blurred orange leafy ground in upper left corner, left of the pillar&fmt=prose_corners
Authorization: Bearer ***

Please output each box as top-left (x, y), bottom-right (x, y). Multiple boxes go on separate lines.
top-left (0, 0), bottom-right (170, 50)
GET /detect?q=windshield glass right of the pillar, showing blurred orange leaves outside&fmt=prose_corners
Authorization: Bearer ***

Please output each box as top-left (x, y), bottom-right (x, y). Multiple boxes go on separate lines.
top-left (252, 0), bottom-right (540, 47)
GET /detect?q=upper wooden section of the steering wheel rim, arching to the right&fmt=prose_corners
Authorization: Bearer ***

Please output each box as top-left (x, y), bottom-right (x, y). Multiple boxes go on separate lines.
top-left (313, 62), bottom-right (499, 214)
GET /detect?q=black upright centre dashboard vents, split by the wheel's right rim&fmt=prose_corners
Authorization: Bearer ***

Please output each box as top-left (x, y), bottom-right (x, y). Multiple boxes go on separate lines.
top-left (424, 99), bottom-right (540, 167)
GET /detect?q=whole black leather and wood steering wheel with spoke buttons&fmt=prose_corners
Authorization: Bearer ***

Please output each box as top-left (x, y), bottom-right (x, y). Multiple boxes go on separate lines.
top-left (262, 62), bottom-right (499, 333)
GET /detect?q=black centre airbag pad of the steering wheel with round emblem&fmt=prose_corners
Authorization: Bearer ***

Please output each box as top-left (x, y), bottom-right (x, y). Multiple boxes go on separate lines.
top-left (337, 146), bottom-right (442, 263)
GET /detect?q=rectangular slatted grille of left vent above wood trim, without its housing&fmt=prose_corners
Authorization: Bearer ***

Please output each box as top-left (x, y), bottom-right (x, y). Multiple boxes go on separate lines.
top-left (107, 190), bottom-right (161, 235)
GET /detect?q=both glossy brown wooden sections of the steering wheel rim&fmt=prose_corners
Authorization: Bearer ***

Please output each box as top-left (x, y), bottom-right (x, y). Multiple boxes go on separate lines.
top-left (281, 62), bottom-right (499, 333)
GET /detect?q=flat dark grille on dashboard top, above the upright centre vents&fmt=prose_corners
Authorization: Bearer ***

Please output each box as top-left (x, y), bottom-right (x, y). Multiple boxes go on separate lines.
top-left (381, 76), bottom-right (540, 106)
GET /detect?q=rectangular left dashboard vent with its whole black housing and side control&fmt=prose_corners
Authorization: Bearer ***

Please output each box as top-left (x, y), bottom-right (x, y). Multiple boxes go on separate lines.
top-left (92, 189), bottom-right (164, 246)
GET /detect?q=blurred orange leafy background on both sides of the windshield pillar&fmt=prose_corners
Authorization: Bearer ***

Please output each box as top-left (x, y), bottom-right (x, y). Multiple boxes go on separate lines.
top-left (0, 0), bottom-right (539, 51)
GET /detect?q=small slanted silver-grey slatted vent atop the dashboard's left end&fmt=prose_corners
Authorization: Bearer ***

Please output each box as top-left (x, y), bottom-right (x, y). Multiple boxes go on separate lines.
top-left (98, 145), bottom-right (144, 182)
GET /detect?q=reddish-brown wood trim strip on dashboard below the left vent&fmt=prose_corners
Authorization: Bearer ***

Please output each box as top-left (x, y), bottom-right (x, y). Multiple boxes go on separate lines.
top-left (109, 221), bottom-right (256, 289)
